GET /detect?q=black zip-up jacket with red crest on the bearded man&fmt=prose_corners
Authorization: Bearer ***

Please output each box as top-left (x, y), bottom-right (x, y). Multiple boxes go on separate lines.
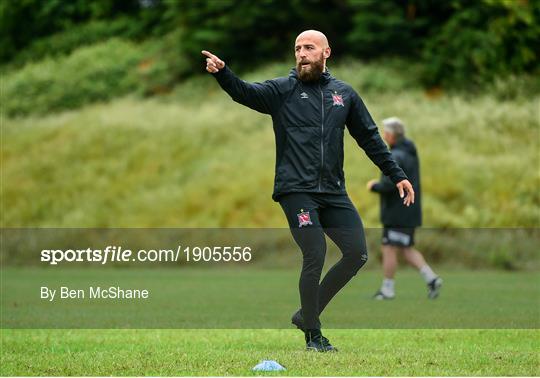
top-left (214, 66), bottom-right (407, 201)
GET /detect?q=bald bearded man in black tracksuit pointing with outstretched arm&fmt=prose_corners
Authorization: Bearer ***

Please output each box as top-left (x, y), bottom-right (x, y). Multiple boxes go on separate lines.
top-left (202, 30), bottom-right (414, 352)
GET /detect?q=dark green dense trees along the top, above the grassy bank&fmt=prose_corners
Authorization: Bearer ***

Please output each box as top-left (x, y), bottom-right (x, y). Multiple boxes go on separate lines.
top-left (0, 0), bottom-right (540, 86)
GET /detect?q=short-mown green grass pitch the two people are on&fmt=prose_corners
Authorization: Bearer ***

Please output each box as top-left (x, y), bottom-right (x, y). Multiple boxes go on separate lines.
top-left (1, 268), bottom-right (540, 376)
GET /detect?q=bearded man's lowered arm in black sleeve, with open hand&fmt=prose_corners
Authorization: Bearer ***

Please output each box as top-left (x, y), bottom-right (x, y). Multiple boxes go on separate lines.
top-left (346, 89), bottom-right (414, 206)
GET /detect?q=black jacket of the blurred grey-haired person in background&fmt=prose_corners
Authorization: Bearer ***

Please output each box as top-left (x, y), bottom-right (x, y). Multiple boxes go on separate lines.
top-left (371, 138), bottom-right (422, 228)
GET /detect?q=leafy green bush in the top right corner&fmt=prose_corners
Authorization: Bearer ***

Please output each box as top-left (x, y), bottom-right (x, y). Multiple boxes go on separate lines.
top-left (424, 0), bottom-right (540, 88)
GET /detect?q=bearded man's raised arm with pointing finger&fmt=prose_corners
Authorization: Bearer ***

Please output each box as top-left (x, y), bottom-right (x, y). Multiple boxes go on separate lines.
top-left (201, 50), bottom-right (281, 114)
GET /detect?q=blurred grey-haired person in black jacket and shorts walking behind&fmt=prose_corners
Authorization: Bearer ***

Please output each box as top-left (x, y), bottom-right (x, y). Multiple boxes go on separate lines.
top-left (367, 117), bottom-right (442, 300)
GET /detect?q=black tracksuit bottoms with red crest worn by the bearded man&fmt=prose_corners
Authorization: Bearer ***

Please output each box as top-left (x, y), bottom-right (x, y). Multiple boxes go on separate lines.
top-left (279, 193), bottom-right (367, 329)
